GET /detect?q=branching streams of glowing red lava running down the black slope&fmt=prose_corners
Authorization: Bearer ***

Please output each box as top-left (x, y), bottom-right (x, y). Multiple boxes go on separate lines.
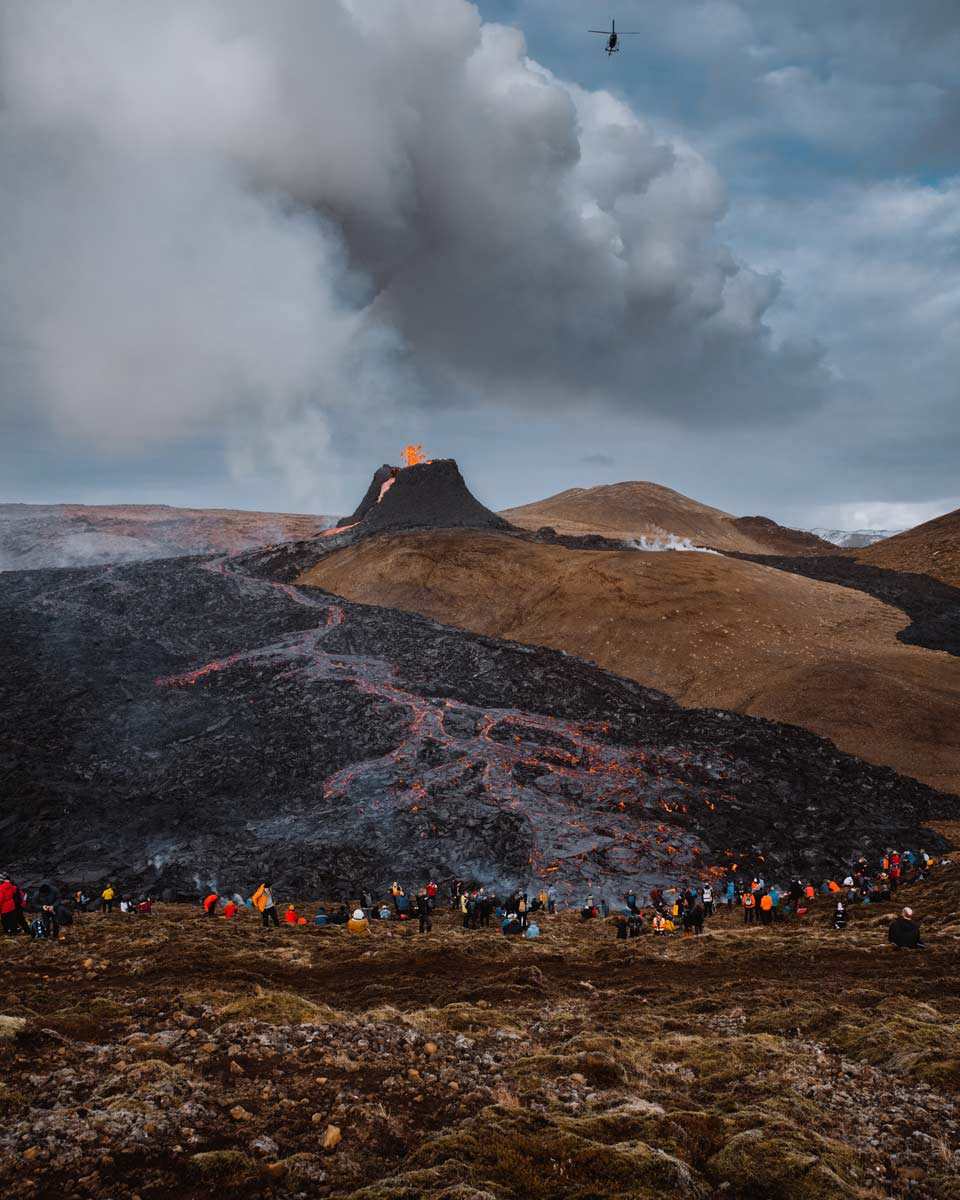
top-left (156, 562), bottom-right (728, 888)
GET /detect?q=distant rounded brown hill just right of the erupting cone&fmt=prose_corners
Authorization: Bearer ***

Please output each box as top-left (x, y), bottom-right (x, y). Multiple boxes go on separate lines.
top-left (500, 481), bottom-right (833, 554)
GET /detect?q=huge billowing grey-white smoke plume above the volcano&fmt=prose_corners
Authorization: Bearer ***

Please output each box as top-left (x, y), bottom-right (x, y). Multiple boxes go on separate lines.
top-left (0, 0), bottom-right (823, 496)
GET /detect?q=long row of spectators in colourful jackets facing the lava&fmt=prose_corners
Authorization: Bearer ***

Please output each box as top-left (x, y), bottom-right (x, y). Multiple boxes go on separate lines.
top-left (0, 850), bottom-right (935, 949)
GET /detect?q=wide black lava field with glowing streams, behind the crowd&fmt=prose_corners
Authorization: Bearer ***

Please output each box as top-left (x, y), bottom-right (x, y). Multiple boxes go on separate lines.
top-left (0, 552), bottom-right (960, 894)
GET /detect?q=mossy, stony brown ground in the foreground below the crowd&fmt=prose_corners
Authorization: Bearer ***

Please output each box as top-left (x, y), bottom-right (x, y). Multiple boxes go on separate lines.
top-left (0, 866), bottom-right (960, 1200)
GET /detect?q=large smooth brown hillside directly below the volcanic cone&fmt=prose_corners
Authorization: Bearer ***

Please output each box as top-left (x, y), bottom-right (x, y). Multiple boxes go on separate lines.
top-left (300, 530), bottom-right (960, 792)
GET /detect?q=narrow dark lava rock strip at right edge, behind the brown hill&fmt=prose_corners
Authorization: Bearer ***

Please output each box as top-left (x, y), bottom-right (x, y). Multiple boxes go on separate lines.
top-left (727, 551), bottom-right (960, 654)
